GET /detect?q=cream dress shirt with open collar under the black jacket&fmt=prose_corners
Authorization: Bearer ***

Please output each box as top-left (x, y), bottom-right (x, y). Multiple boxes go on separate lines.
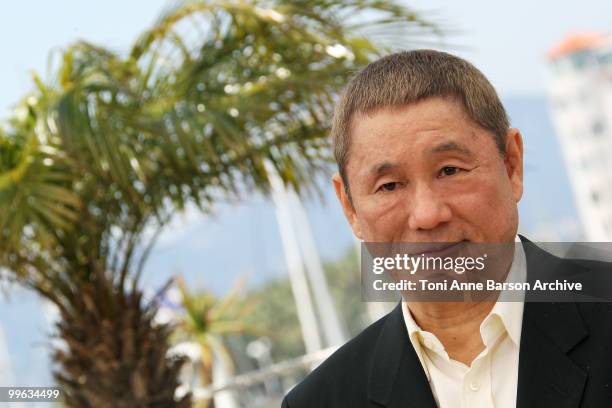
top-left (402, 237), bottom-right (527, 408)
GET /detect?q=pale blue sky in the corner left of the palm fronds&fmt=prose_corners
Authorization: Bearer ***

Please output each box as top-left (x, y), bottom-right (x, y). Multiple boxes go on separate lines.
top-left (0, 0), bottom-right (168, 118)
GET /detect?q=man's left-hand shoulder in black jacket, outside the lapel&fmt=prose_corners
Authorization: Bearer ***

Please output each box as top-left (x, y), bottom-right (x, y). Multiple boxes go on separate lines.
top-left (283, 315), bottom-right (389, 408)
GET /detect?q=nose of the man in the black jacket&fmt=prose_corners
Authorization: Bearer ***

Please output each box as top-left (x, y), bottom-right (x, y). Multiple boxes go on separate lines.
top-left (408, 186), bottom-right (452, 231)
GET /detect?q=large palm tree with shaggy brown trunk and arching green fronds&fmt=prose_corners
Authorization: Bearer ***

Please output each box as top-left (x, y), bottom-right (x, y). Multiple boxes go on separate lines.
top-left (0, 0), bottom-right (435, 407)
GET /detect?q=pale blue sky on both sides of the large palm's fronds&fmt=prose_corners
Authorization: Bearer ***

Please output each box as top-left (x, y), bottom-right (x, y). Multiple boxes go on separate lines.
top-left (0, 0), bottom-right (612, 118)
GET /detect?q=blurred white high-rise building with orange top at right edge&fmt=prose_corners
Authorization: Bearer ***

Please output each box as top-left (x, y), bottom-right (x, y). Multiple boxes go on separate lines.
top-left (547, 33), bottom-right (612, 241)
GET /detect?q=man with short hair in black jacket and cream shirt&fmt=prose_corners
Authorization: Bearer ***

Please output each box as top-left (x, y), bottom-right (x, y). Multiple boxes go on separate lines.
top-left (283, 50), bottom-right (612, 408)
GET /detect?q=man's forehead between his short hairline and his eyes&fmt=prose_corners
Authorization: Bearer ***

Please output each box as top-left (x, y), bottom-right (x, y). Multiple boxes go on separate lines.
top-left (347, 97), bottom-right (495, 179)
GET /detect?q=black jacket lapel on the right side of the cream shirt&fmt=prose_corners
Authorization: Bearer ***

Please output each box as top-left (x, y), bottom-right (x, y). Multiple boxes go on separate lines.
top-left (517, 237), bottom-right (588, 408)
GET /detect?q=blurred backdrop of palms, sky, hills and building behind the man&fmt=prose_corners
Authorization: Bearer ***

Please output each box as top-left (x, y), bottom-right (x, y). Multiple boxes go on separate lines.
top-left (0, 0), bottom-right (612, 408)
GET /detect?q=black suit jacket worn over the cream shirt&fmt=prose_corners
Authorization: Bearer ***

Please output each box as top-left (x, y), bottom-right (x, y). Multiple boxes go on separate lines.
top-left (282, 237), bottom-right (612, 408)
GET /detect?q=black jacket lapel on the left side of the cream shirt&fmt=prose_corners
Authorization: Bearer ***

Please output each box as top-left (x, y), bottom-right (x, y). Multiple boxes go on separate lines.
top-left (368, 303), bottom-right (436, 408)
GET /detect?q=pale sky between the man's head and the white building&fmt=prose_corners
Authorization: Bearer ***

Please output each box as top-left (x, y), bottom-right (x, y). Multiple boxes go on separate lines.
top-left (404, 0), bottom-right (612, 96)
